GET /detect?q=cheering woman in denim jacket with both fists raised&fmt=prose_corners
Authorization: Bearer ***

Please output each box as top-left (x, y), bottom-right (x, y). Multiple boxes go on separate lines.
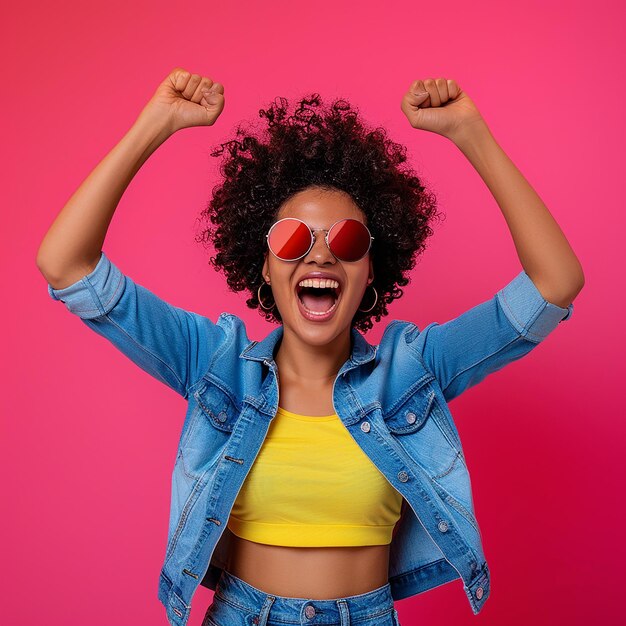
top-left (37, 68), bottom-right (584, 626)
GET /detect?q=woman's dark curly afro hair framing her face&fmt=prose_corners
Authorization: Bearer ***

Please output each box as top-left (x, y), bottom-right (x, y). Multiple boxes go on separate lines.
top-left (196, 93), bottom-right (442, 332)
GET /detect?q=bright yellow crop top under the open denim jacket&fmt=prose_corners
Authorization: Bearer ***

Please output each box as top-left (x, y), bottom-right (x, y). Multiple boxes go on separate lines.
top-left (227, 407), bottom-right (402, 547)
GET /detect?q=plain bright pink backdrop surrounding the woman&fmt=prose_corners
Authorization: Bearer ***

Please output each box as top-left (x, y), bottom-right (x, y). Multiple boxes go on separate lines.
top-left (0, 0), bottom-right (626, 626)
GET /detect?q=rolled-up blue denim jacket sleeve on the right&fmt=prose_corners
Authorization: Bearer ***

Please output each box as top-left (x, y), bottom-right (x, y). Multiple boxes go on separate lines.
top-left (411, 270), bottom-right (574, 401)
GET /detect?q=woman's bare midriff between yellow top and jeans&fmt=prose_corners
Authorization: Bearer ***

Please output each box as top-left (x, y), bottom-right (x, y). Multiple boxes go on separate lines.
top-left (226, 534), bottom-right (389, 600)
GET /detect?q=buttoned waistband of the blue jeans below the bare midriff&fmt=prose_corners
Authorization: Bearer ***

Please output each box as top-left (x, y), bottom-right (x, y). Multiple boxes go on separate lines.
top-left (215, 570), bottom-right (394, 624)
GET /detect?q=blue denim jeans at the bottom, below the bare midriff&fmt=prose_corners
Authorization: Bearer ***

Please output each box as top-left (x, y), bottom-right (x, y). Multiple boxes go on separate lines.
top-left (202, 570), bottom-right (400, 626)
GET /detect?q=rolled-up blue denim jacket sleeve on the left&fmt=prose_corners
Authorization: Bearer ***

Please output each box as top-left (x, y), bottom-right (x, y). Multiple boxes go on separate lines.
top-left (48, 252), bottom-right (224, 398)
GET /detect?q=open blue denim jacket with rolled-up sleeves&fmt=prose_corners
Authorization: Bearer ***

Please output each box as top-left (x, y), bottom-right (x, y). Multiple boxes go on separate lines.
top-left (48, 252), bottom-right (573, 626)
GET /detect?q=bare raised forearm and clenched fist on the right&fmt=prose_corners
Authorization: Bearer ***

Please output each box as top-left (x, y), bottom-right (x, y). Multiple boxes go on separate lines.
top-left (401, 78), bottom-right (585, 308)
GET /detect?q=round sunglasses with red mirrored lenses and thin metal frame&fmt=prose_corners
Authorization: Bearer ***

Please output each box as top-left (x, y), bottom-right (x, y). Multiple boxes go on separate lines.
top-left (265, 217), bottom-right (374, 262)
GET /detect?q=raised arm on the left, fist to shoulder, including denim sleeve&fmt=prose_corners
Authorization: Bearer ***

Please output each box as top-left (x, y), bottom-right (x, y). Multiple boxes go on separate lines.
top-left (37, 68), bottom-right (224, 397)
